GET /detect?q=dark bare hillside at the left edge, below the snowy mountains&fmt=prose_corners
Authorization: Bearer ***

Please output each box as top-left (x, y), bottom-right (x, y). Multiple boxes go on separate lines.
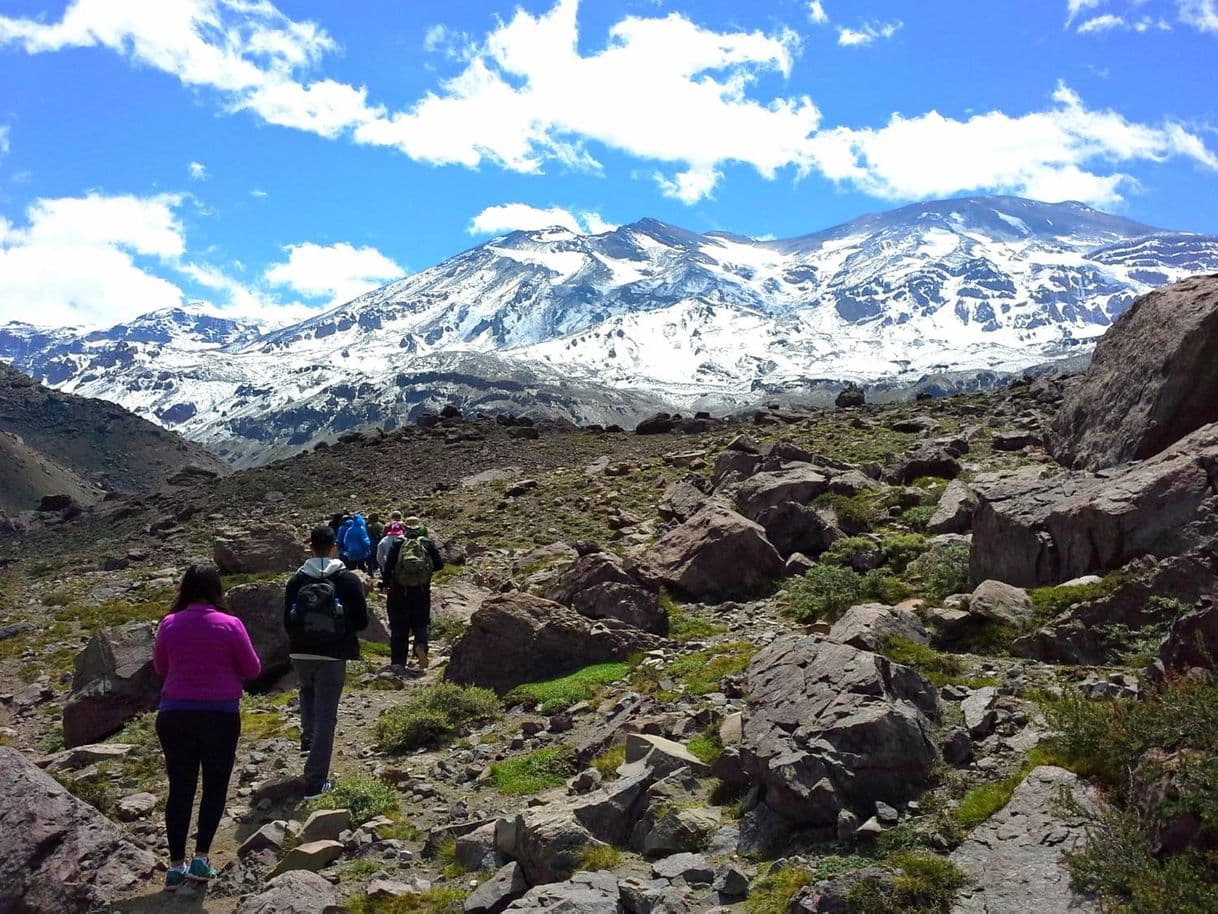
top-left (0, 364), bottom-right (227, 512)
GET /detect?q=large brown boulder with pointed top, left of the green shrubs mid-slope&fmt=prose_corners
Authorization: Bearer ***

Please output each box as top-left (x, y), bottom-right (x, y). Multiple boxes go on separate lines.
top-left (638, 500), bottom-right (783, 600)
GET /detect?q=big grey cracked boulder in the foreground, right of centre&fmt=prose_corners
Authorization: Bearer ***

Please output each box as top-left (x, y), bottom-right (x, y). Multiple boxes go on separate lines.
top-left (739, 635), bottom-right (939, 827)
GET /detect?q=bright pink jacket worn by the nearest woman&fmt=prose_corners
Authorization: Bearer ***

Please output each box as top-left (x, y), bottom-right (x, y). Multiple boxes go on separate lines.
top-left (152, 603), bottom-right (262, 702)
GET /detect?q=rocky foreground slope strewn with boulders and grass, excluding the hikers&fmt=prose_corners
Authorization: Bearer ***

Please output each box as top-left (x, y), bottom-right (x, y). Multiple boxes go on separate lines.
top-left (0, 277), bottom-right (1218, 914)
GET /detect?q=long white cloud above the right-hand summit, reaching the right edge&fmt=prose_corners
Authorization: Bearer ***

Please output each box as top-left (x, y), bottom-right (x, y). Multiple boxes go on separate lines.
top-left (811, 84), bottom-right (1218, 205)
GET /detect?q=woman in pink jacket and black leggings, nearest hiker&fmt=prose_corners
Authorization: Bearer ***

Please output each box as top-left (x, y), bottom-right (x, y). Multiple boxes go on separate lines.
top-left (152, 564), bottom-right (262, 892)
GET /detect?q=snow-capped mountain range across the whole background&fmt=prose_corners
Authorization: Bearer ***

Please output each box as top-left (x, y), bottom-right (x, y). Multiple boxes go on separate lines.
top-left (0, 197), bottom-right (1218, 463)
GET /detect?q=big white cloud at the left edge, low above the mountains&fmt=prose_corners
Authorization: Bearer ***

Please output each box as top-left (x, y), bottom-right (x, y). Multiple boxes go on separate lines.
top-left (0, 194), bottom-right (184, 324)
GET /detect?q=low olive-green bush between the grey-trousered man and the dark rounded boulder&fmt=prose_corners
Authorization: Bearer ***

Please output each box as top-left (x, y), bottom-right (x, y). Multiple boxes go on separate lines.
top-left (375, 682), bottom-right (502, 752)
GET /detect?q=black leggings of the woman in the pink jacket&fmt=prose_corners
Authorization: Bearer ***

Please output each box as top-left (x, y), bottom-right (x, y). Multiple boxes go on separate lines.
top-left (156, 710), bottom-right (241, 860)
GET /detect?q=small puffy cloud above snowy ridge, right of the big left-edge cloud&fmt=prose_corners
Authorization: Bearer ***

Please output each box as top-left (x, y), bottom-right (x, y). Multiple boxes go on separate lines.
top-left (263, 241), bottom-right (406, 305)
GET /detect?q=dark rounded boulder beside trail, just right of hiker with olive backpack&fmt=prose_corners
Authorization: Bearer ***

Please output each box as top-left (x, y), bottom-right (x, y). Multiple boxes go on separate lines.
top-left (445, 593), bottom-right (665, 692)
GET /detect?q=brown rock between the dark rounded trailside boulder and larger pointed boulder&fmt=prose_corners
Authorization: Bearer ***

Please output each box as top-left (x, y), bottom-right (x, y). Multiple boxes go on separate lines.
top-left (548, 552), bottom-right (669, 635)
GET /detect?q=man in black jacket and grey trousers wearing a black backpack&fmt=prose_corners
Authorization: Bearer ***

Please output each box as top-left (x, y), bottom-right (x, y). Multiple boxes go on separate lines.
top-left (284, 526), bottom-right (368, 799)
